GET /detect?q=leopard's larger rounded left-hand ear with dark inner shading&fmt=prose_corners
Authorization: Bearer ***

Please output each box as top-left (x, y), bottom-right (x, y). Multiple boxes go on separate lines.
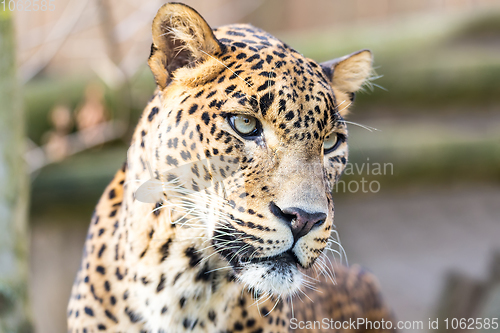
top-left (148, 2), bottom-right (222, 89)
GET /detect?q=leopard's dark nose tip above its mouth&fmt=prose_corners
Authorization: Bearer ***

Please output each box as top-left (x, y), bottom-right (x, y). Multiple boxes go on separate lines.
top-left (270, 202), bottom-right (327, 242)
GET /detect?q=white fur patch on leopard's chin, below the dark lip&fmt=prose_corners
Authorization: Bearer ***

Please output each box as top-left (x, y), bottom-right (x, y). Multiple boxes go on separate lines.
top-left (238, 262), bottom-right (303, 296)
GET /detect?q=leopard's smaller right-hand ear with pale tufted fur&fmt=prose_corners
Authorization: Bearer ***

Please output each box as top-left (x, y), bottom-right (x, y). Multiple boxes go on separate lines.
top-left (321, 50), bottom-right (373, 113)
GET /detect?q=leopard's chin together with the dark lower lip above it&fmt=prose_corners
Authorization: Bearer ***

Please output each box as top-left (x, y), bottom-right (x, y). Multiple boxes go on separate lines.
top-left (235, 251), bottom-right (304, 297)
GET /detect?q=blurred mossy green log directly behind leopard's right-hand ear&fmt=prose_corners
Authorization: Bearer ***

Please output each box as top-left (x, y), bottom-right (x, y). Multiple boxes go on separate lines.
top-left (283, 12), bottom-right (500, 109)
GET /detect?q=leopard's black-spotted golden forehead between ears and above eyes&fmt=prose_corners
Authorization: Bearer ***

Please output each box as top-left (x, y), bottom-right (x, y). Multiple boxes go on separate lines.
top-left (163, 25), bottom-right (345, 147)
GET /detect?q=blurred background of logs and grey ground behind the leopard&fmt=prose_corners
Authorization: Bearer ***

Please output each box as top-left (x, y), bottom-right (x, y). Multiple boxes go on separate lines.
top-left (0, 0), bottom-right (500, 333)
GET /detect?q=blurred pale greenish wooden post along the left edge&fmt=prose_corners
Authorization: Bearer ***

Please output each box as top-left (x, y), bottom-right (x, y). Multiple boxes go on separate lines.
top-left (0, 8), bottom-right (32, 333)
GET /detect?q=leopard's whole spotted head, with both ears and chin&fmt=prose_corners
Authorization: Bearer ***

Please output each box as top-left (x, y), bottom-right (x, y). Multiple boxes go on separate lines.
top-left (144, 4), bottom-right (372, 295)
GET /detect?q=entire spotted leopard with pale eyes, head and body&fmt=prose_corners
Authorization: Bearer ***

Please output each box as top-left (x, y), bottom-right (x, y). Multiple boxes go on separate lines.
top-left (67, 2), bottom-right (394, 333)
